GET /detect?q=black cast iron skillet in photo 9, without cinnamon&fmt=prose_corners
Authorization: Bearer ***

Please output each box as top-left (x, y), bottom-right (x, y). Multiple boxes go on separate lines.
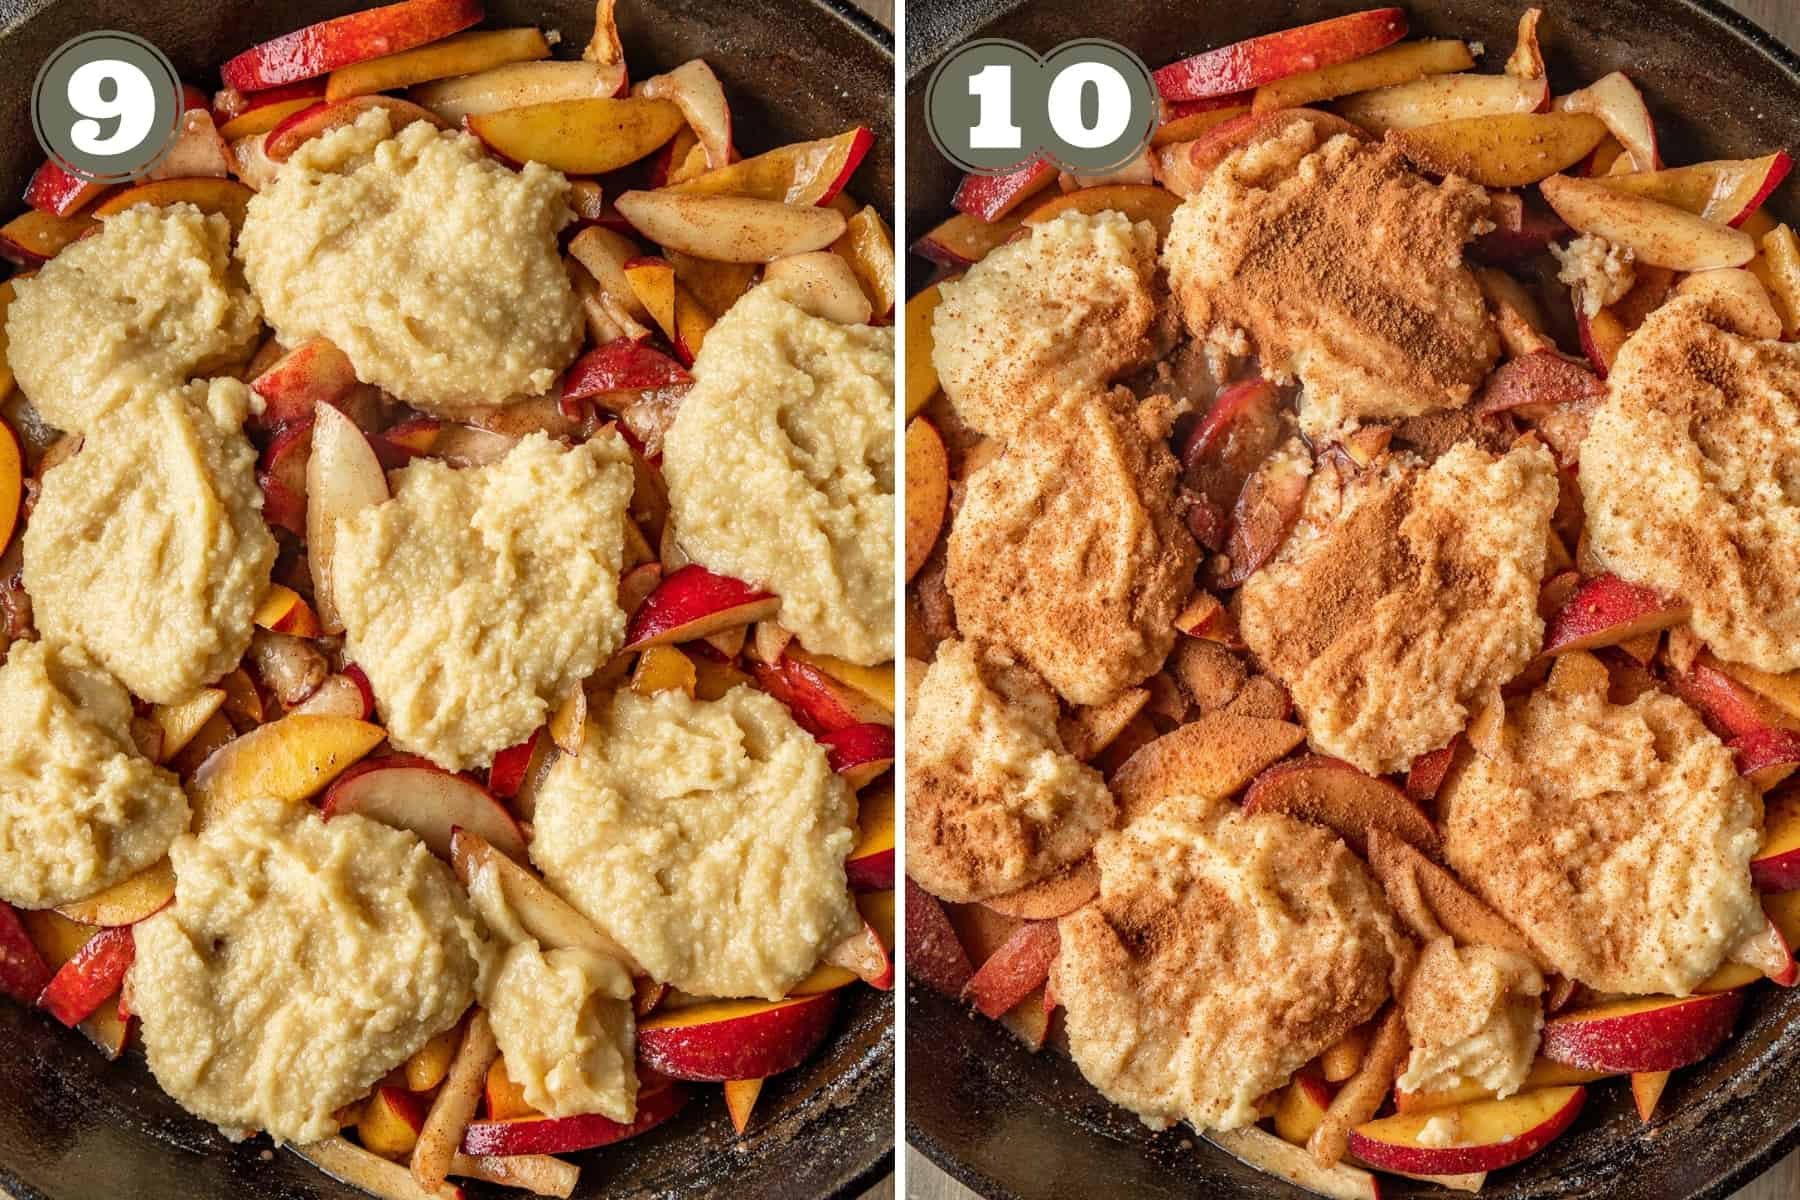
top-left (0, 0), bottom-right (895, 1200)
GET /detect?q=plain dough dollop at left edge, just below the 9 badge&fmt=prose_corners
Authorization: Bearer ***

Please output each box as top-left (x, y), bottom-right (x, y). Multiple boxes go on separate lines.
top-left (5, 203), bottom-right (261, 434)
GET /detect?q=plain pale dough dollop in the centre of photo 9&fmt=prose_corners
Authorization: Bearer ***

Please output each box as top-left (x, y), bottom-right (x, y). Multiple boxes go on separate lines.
top-left (331, 434), bottom-right (632, 770)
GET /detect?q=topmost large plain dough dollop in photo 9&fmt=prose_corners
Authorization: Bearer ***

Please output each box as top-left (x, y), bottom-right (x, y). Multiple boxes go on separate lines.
top-left (238, 110), bottom-right (581, 416)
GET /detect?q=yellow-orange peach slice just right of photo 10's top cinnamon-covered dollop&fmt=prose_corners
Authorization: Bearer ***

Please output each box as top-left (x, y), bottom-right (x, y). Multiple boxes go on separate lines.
top-left (1391, 112), bottom-right (1606, 188)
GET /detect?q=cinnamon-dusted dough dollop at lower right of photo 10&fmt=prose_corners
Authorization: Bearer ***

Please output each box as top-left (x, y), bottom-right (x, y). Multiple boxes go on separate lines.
top-left (1440, 665), bottom-right (1762, 995)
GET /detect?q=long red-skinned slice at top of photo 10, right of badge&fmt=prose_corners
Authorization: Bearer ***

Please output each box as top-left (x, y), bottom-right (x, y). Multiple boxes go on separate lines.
top-left (1154, 9), bottom-right (1406, 101)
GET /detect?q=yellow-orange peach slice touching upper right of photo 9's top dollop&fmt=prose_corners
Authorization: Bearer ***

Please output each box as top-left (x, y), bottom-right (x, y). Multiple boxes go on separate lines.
top-left (464, 97), bottom-right (684, 173)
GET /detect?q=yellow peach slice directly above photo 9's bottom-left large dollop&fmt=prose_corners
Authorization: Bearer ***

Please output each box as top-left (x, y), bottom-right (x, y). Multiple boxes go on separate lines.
top-left (193, 714), bottom-right (387, 824)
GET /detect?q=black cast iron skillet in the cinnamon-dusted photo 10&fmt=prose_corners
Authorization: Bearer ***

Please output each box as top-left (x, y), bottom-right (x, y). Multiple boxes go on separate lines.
top-left (907, 0), bottom-right (1800, 1200)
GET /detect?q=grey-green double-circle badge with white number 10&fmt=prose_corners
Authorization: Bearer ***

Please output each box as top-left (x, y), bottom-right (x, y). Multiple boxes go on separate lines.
top-left (925, 38), bottom-right (1161, 175)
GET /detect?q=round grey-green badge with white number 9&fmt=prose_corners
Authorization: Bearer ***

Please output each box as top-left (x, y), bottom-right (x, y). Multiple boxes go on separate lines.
top-left (31, 31), bottom-right (182, 184)
